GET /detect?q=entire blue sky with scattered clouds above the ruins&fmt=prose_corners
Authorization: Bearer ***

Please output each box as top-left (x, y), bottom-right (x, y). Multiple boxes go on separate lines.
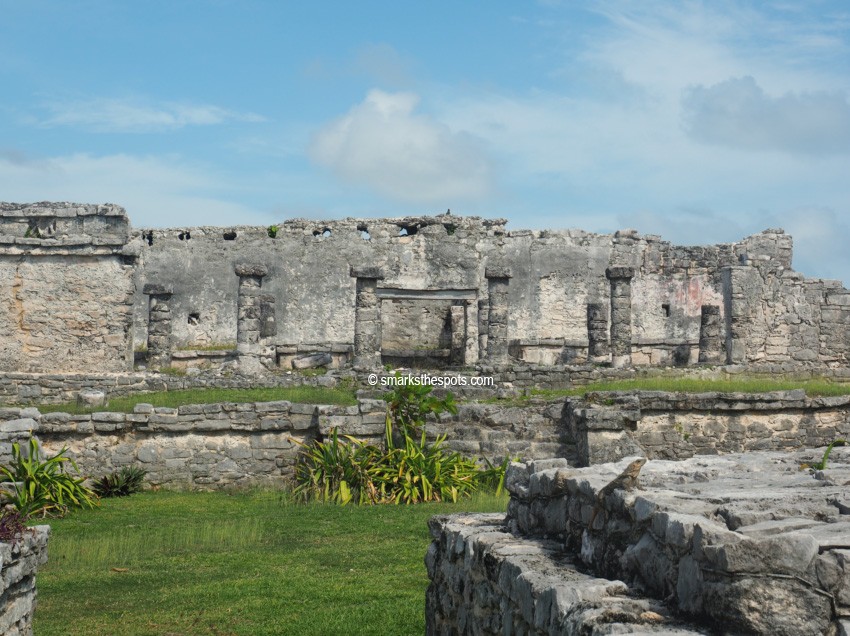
top-left (0, 0), bottom-right (850, 282)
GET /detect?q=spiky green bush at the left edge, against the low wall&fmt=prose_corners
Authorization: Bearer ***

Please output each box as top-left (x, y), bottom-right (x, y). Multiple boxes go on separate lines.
top-left (0, 438), bottom-right (97, 517)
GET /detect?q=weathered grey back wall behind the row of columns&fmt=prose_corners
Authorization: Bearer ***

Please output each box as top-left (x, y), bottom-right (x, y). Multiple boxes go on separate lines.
top-left (136, 216), bottom-right (843, 366)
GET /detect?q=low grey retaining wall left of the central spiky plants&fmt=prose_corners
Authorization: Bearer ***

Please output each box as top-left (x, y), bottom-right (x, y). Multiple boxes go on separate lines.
top-left (0, 400), bottom-right (385, 488)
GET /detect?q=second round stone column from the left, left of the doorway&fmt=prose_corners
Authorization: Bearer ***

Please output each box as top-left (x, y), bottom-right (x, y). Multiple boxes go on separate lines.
top-left (235, 263), bottom-right (274, 373)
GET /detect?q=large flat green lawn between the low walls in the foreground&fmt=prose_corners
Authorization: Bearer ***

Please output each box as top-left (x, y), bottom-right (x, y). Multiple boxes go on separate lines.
top-left (34, 492), bottom-right (507, 636)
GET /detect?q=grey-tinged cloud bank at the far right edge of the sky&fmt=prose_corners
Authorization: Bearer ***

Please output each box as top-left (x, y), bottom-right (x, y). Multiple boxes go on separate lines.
top-left (682, 77), bottom-right (850, 154)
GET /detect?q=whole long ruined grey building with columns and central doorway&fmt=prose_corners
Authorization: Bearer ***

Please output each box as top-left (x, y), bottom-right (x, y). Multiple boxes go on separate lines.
top-left (0, 203), bottom-right (850, 372)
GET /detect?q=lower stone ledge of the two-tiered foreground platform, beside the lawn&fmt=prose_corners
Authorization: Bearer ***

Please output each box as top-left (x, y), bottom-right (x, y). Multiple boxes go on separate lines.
top-left (425, 514), bottom-right (704, 636)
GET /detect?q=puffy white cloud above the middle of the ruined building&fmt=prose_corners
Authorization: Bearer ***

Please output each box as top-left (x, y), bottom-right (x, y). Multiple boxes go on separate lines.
top-left (310, 90), bottom-right (492, 203)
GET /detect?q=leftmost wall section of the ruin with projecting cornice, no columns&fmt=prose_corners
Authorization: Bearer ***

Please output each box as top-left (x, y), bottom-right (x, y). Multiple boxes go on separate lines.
top-left (0, 204), bottom-right (135, 372)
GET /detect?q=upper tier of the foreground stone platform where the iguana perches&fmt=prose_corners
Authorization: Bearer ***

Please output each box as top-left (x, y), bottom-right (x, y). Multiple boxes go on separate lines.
top-left (506, 448), bottom-right (850, 636)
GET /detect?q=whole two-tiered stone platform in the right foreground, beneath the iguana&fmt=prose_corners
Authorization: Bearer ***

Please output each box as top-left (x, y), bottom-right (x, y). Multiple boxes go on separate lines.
top-left (426, 448), bottom-right (850, 636)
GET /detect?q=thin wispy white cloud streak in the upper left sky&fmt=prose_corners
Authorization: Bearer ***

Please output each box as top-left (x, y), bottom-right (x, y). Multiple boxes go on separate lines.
top-left (39, 99), bottom-right (264, 133)
